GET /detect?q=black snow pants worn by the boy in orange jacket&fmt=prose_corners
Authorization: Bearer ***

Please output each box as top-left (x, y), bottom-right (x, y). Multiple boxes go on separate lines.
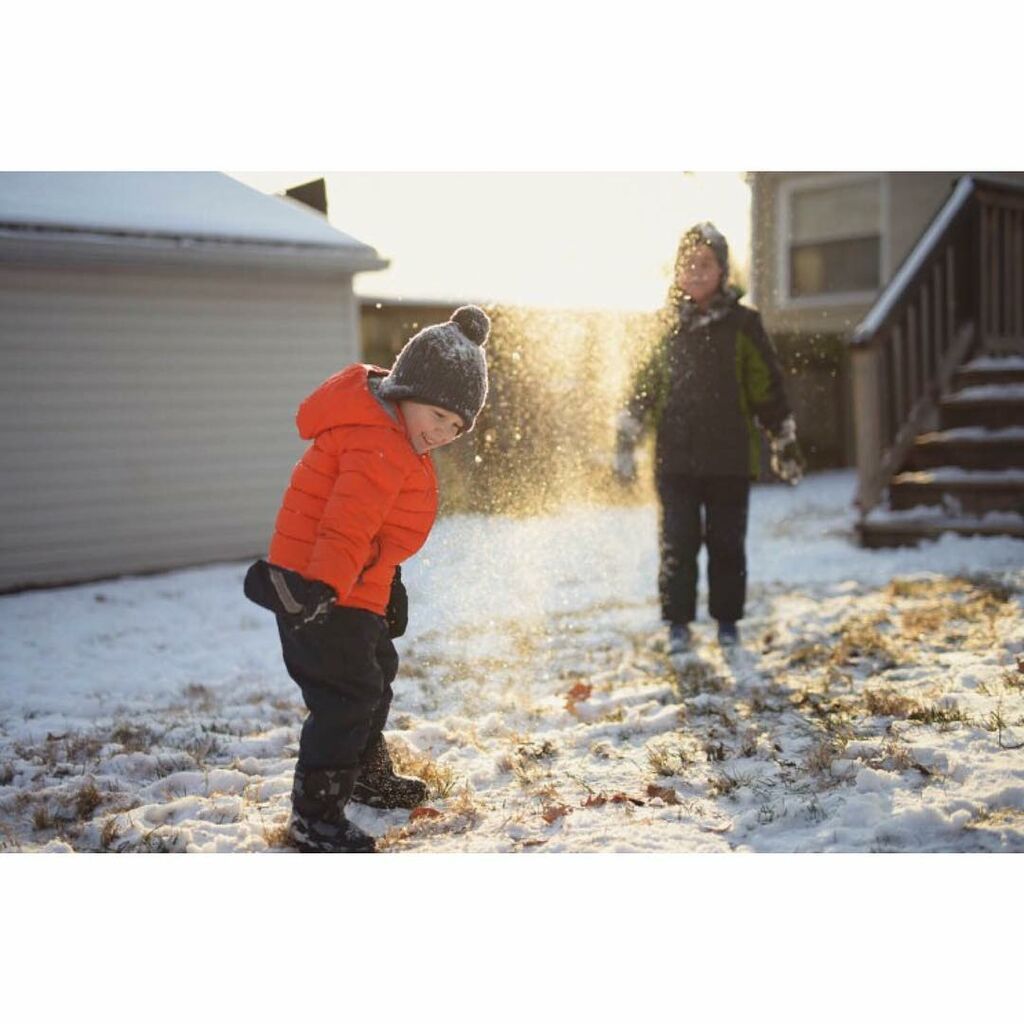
top-left (278, 605), bottom-right (398, 769)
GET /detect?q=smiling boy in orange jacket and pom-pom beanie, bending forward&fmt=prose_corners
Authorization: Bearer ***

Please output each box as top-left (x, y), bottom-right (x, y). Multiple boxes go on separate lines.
top-left (267, 306), bottom-right (490, 853)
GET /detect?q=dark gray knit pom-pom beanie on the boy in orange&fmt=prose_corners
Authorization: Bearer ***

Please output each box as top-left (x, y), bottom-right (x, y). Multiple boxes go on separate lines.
top-left (378, 306), bottom-right (490, 433)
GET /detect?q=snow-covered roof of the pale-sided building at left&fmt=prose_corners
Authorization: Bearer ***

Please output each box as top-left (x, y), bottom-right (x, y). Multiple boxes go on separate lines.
top-left (0, 171), bottom-right (386, 268)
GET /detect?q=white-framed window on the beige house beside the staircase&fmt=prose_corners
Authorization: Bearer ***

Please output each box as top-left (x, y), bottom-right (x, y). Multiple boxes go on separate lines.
top-left (785, 176), bottom-right (882, 299)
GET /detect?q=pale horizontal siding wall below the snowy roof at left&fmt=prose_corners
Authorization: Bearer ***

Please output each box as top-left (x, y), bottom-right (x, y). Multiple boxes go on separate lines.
top-left (0, 263), bottom-right (359, 590)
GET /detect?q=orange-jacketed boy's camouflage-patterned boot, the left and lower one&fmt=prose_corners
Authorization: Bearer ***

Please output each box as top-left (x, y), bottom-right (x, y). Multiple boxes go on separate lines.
top-left (288, 765), bottom-right (377, 853)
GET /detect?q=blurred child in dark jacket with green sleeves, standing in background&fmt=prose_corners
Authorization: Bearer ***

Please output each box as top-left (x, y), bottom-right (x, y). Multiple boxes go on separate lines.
top-left (615, 221), bottom-right (803, 654)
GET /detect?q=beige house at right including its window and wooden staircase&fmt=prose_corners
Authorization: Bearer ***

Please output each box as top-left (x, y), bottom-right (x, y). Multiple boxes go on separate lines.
top-left (750, 172), bottom-right (1024, 544)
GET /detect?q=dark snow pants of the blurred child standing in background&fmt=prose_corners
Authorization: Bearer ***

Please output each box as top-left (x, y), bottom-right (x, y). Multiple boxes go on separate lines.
top-left (657, 473), bottom-right (751, 623)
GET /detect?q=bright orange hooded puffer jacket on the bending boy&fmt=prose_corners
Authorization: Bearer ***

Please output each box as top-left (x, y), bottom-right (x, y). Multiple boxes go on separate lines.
top-left (267, 364), bottom-right (437, 615)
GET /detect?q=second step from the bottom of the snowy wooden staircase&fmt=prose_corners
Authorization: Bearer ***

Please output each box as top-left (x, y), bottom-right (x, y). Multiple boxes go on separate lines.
top-left (889, 466), bottom-right (1024, 514)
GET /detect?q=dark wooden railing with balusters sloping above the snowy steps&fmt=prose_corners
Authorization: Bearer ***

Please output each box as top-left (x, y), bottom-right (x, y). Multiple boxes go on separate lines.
top-left (851, 175), bottom-right (1024, 515)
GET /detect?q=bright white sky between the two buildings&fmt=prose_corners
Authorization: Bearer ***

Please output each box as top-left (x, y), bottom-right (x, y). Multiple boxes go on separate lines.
top-left (230, 171), bottom-right (750, 310)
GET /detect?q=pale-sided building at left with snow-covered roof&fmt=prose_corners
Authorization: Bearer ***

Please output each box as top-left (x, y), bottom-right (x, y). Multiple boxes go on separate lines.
top-left (0, 172), bottom-right (387, 590)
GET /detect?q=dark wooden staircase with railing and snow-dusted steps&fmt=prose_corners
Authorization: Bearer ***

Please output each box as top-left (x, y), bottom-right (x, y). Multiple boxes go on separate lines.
top-left (852, 177), bottom-right (1024, 547)
